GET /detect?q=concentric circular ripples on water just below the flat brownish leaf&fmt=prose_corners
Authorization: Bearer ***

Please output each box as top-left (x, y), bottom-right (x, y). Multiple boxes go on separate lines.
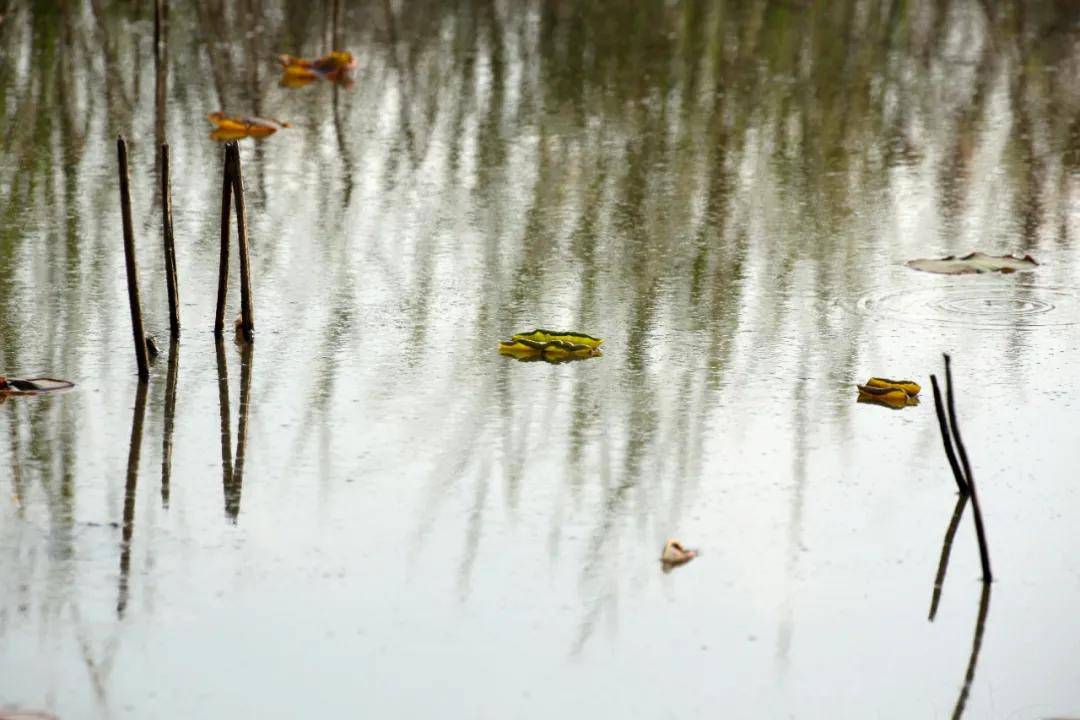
top-left (856, 285), bottom-right (1080, 327)
